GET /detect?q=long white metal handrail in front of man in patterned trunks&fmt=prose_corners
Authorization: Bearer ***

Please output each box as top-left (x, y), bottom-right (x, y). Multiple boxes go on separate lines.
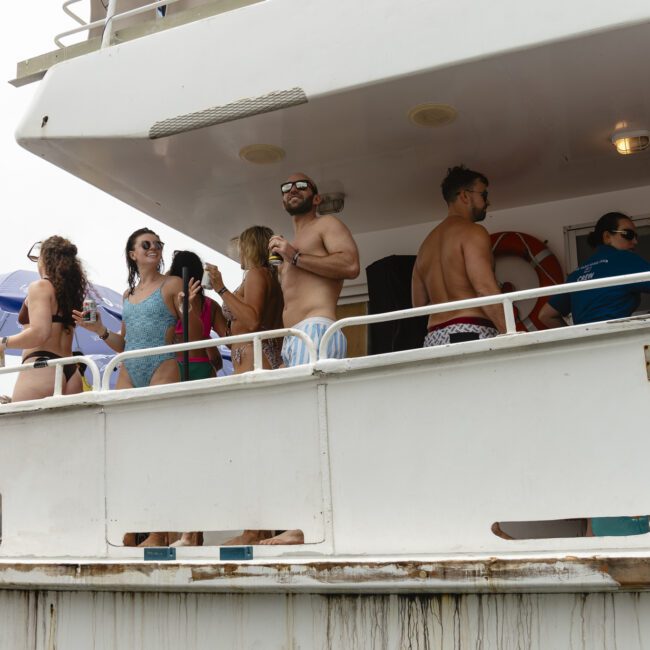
top-left (318, 271), bottom-right (650, 359)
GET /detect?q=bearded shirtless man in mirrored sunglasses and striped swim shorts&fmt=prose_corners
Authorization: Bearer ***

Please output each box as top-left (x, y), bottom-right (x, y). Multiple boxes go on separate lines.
top-left (269, 173), bottom-right (359, 366)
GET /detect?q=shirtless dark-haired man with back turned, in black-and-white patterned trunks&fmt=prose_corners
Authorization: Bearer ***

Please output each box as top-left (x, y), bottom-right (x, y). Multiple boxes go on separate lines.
top-left (411, 165), bottom-right (506, 347)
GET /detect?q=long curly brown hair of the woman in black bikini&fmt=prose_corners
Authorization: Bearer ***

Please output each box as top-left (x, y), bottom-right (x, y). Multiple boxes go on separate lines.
top-left (39, 235), bottom-right (88, 331)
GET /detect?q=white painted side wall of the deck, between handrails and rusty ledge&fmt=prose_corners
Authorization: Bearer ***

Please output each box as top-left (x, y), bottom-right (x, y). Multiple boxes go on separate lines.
top-left (0, 319), bottom-right (650, 558)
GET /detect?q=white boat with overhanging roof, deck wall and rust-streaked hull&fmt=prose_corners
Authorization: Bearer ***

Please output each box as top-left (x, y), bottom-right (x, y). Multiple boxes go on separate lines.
top-left (0, 0), bottom-right (650, 650)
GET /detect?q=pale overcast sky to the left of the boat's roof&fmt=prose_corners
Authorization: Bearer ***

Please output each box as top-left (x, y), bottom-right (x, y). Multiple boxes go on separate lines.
top-left (0, 0), bottom-right (241, 393)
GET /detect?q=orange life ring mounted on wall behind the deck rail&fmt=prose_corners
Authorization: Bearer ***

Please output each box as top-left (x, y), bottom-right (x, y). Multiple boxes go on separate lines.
top-left (490, 232), bottom-right (564, 332)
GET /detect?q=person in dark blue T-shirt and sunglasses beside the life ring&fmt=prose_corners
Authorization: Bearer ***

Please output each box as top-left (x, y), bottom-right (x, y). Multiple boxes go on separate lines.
top-left (539, 212), bottom-right (650, 327)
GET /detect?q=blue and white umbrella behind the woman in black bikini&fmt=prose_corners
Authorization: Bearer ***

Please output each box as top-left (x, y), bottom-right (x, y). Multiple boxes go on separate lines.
top-left (0, 271), bottom-right (122, 356)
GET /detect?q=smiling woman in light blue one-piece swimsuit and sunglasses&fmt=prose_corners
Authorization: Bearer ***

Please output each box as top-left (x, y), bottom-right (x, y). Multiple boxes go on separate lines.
top-left (74, 228), bottom-right (202, 389)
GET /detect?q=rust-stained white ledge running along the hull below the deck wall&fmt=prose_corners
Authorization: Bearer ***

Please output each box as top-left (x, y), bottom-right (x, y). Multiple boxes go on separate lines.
top-left (0, 556), bottom-right (650, 592)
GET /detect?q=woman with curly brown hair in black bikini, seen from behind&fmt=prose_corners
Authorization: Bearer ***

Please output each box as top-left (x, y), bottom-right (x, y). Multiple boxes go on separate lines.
top-left (0, 235), bottom-right (87, 402)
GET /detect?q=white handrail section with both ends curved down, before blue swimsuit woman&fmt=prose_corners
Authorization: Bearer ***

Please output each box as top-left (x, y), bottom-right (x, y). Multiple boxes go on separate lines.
top-left (101, 327), bottom-right (318, 391)
